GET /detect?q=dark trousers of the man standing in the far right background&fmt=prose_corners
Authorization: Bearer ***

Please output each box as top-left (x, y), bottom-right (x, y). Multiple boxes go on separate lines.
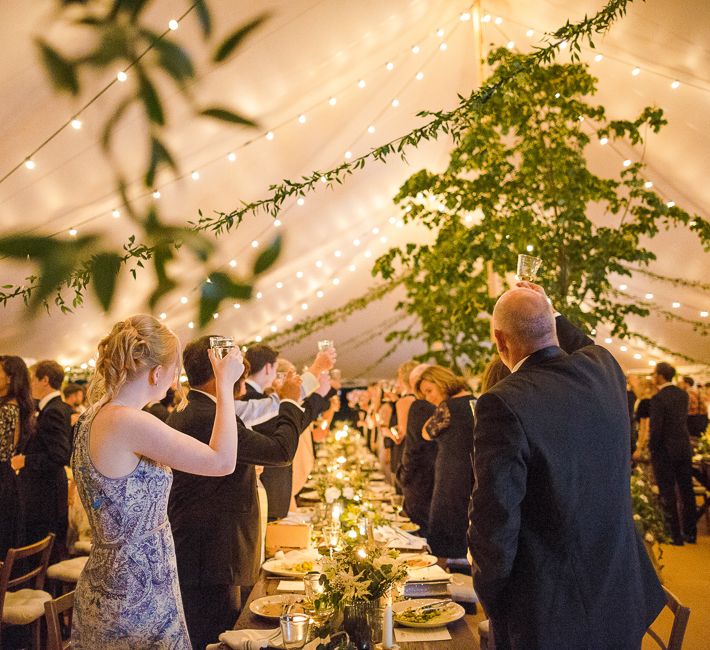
top-left (651, 455), bottom-right (696, 541)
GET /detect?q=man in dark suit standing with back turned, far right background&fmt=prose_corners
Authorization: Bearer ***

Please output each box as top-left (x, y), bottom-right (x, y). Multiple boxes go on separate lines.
top-left (648, 362), bottom-right (697, 546)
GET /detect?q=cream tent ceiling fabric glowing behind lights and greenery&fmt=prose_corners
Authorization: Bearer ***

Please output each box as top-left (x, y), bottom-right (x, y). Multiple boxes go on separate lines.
top-left (0, 0), bottom-right (710, 377)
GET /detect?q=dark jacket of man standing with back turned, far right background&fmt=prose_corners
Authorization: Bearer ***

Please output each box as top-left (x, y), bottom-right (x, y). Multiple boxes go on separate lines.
top-left (648, 386), bottom-right (692, 462)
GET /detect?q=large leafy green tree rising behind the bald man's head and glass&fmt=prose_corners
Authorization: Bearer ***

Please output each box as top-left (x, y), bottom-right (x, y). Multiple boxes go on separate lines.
top-left (375, 48), bottom-right (710, 372)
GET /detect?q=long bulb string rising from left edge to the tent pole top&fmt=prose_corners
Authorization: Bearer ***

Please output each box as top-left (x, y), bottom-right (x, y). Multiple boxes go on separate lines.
top-left (6, 5), bottom-right (472, 243)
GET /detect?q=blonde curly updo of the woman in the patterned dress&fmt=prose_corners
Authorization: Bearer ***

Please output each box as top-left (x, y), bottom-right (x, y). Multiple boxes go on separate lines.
top-left (88, 314), bottom-right (181, 404)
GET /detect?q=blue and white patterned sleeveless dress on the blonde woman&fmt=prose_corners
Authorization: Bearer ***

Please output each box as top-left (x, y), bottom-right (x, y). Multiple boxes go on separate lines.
top-left (72, 409), bottom-right (191, 650)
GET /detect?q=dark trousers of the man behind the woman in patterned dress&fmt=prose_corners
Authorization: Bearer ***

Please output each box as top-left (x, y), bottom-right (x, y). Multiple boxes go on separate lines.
top-left (181, 585), bottom-right (237, 650)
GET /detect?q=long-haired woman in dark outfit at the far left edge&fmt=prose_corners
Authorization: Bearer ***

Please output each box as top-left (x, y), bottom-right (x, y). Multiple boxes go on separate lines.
top-left (0, 356), bottom-right (35, 558)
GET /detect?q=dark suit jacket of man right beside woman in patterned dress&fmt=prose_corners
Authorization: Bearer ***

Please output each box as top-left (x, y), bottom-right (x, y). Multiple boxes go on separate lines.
top-left (167, 391), bottom-right (303, 587)
